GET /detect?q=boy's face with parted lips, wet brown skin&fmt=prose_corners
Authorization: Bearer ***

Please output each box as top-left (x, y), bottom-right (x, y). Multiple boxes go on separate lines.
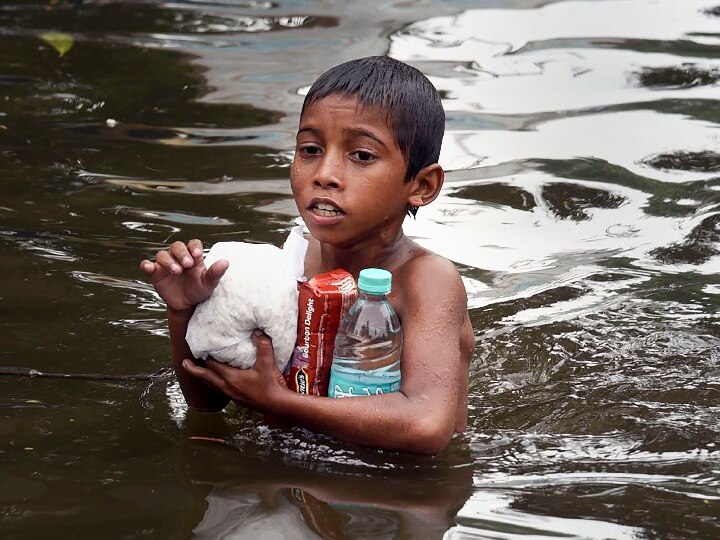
top-left (290, 95), bottom-right (413, 247)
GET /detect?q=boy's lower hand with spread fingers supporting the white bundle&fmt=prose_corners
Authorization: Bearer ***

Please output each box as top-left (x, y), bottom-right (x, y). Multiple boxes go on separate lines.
top-left (182, 330), bottom-right (287, 412)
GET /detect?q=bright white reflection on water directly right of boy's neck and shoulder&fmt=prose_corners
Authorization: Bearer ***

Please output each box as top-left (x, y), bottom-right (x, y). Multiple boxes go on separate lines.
top-left (405, 171), bottom-right (720, 280)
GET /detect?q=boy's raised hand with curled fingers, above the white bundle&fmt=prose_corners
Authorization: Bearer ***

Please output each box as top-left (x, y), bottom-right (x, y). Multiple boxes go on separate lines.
top-left (140, 240), bottom-right (229, 311)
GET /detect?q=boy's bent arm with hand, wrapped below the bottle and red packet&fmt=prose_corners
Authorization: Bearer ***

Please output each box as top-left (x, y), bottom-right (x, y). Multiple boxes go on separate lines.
top-left (183, 257), bottom-right (472, 454)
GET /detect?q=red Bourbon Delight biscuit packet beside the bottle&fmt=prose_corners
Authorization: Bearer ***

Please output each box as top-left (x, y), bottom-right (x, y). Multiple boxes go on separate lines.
top-left (283, 269), bottom-right (358, 396)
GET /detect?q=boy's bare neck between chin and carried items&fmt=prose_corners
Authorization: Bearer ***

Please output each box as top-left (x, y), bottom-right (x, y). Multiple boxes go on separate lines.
top-left (320, 229), bottom-right (408, 279)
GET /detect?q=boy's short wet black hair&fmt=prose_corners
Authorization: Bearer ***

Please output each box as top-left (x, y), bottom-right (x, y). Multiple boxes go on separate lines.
top-left (300, 56), bottom-right (445, 216)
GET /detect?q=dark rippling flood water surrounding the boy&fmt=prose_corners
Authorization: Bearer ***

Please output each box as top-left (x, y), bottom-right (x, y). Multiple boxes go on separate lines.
top-left (0, 0), bottom-right (720, 540)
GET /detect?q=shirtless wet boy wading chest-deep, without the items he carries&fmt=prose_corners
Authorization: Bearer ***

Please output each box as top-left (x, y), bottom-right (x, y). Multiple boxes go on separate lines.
top-left (140, 56), bottom-right (475, 454)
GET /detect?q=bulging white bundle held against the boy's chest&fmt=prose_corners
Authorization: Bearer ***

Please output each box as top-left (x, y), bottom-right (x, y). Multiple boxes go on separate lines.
top-left (185, 227), bottom-right (307, 371)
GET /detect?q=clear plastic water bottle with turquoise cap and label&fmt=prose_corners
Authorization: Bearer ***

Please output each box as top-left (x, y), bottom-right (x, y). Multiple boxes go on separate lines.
top-left (328, 268), bottom-right (403, 398)
